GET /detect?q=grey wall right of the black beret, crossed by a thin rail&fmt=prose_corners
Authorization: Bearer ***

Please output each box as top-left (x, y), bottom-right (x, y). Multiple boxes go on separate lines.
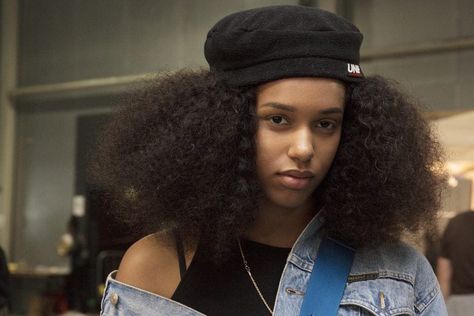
top-left (351, 0), bottom-right (474, 111)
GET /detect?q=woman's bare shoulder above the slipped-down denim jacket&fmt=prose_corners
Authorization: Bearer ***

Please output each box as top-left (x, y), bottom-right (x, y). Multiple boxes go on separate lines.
top-left (116, 234), bottom-right (190, 298)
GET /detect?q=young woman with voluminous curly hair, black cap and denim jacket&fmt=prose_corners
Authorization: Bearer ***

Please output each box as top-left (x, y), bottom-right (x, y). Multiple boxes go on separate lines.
top-left (96, 6), bottom-right (446, 315)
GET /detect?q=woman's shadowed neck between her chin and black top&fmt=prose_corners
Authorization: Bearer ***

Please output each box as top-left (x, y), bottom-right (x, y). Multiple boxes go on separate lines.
top-left (244, 201), bottom-right (317, 248)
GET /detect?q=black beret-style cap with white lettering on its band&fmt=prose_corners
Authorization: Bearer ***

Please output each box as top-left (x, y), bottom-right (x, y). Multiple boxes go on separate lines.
top-left (204, 5), bottom-right (364, 86)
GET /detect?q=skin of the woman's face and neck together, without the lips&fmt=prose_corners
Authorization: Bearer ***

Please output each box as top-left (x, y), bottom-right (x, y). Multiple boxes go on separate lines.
top-left (247, 78), bottom-right (345, 247)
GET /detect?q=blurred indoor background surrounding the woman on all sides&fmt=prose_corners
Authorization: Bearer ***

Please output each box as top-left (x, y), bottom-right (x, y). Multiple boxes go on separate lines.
top-left (0, 0), bottom-right (474, 315)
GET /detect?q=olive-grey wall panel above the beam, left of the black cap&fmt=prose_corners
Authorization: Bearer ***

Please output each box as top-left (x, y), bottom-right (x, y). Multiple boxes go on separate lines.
top-left (19, 0), bottom-right (297, 86)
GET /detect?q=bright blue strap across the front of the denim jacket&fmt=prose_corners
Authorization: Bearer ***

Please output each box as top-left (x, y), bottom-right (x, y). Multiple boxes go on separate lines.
top-left (300, 238), bottom-right (355, 316)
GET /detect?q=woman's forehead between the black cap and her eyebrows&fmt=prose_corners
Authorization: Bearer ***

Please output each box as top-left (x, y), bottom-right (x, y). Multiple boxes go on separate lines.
top-left (257, 77), bottom-right (345, 108)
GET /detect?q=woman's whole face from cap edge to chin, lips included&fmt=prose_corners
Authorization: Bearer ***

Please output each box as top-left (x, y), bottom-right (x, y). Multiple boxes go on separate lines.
top-left (256, 77), bottom-right (345, 209)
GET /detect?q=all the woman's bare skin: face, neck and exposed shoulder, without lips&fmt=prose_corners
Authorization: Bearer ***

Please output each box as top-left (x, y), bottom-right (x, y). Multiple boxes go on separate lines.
top-left (116, 77), bottom-right (345, 298)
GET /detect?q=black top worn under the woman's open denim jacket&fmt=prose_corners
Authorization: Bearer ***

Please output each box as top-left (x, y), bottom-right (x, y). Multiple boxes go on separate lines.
top-left (172, 240), bottom-right (291, 316)
